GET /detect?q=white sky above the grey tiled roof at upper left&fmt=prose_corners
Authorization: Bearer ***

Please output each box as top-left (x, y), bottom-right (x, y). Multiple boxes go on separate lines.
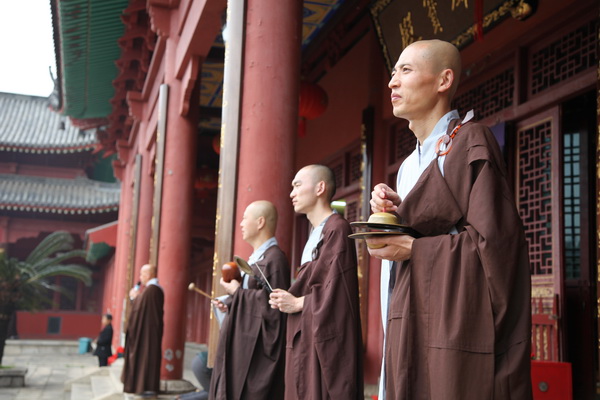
top-left (0, 0), bottom-right (56, 97)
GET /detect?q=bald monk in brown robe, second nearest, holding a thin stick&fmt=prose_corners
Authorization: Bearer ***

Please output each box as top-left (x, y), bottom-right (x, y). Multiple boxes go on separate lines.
top-left (270, 165), bottom-right (364, 400)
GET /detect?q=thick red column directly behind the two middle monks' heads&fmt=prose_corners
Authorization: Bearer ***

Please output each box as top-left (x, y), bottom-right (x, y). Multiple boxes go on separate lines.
top-left (234, 0), bottom-right (302, 256)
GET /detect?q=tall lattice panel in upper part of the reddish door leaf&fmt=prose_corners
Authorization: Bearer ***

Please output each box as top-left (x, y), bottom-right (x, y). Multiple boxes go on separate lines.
top-left (518, 120), bottom-right (552, 275)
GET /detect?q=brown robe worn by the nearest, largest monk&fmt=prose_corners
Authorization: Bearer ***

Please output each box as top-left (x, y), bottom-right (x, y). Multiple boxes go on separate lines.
top-left (385, 121), bottom-right (531, 400)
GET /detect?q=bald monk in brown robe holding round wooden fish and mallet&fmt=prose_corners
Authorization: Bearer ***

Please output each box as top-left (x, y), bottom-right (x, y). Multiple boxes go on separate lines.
top-left (209, 200), bottom-right (290, 400)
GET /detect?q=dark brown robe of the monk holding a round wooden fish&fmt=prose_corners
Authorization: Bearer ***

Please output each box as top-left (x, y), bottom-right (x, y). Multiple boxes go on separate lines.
top-left (209, 246), bottom-right (290, 400)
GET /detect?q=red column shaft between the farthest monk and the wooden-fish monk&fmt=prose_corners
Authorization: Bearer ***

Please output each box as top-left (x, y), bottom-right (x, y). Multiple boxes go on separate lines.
top-left (157, 43), bottom-right (200, 380)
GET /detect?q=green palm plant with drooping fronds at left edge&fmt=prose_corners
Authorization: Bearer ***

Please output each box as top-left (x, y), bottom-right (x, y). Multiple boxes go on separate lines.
top-left (0, 231), bottom-right (92, 365)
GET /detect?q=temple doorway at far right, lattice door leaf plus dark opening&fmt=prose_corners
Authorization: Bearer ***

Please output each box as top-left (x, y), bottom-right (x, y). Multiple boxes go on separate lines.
top-left (515, 92), bottom-right (598, 399)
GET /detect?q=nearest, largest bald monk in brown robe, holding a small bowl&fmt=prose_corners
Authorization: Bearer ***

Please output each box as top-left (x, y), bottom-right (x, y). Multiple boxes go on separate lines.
top-left (368, 40), bottom-right (532, 400)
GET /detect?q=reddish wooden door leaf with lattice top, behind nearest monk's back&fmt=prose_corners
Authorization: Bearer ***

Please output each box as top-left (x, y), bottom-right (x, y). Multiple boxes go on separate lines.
top-left (515, 107), bottom-right (564, 361)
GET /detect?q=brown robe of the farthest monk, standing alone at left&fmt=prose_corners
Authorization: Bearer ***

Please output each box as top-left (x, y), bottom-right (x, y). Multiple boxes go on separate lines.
top-left (121, 285), bottom-right (164, 393)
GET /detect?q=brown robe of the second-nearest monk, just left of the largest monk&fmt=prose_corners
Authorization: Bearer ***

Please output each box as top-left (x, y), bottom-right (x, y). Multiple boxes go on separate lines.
top-left (285, 214), bottom-right (364, 400)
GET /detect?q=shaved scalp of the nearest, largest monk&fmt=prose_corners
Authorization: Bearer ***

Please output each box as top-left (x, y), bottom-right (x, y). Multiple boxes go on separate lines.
top-left (405, 39), bottom-right (462, 99)
